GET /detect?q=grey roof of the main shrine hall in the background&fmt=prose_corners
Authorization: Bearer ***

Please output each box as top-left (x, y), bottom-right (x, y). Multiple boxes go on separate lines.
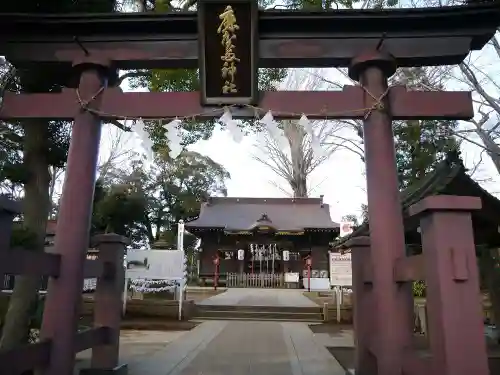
top-left (186, 197), bottom-right (339, 231)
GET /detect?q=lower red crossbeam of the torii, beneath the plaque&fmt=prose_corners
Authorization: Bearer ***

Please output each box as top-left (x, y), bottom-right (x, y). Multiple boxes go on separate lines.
top-left (0, 86), bottom-right (474, 121)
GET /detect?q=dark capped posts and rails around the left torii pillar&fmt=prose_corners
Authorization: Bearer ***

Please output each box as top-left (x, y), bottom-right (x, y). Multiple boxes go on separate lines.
top-left (0, 196), bottom-right (126, 375)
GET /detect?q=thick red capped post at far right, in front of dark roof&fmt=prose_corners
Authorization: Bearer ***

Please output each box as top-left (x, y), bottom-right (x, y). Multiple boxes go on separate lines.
top-left (409, 195), bottom-right (489, 375)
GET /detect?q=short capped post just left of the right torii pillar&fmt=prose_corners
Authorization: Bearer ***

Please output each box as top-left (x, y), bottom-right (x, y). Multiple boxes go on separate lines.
top-left (343, 237), bottom-right (377, 375)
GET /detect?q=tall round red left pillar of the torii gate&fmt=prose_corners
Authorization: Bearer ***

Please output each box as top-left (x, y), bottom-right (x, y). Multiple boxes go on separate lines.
top-left (41, 56), bottom-right (108, 375)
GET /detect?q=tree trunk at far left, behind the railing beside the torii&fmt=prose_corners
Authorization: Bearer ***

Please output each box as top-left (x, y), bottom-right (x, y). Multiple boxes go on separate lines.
top-left (0, 121), bottom-right (50, 349)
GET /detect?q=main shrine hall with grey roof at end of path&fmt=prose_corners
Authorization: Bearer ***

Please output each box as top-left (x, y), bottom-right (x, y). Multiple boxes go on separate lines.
top-left (186, 196), bottom-right (339, 287)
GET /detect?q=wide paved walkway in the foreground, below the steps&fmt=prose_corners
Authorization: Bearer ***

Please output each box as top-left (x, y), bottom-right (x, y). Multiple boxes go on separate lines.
top-left (78, 321), bottom-right (345, 375)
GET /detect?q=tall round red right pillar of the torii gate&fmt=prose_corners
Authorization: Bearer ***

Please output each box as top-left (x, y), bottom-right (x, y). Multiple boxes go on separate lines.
top-left (349, 50), bottom-right (413, 375)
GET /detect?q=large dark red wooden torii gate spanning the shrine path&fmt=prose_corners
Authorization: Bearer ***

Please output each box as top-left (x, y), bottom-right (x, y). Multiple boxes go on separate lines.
top-left (0, 0), bottom-right (500, 375)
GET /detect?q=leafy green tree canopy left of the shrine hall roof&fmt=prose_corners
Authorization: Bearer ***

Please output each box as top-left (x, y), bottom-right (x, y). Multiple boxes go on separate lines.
top-left (92, 151), bottom-right (230, 247)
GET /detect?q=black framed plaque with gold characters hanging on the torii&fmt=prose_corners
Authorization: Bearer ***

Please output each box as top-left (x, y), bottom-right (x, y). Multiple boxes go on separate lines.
top-left (197, 0), bottom-right (258, 106)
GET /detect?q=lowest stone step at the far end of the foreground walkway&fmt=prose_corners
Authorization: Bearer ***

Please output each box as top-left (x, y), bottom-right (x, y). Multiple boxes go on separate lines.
top-left (194, 310), bottom-right (323, 322)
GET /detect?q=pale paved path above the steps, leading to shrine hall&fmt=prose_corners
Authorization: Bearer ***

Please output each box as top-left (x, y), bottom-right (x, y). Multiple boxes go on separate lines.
top-left (197, 288), bottom-right (318, 307)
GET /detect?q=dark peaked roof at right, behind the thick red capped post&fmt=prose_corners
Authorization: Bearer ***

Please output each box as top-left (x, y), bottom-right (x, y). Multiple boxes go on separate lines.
top-left (334, 152), bottom-right (500, 247)
